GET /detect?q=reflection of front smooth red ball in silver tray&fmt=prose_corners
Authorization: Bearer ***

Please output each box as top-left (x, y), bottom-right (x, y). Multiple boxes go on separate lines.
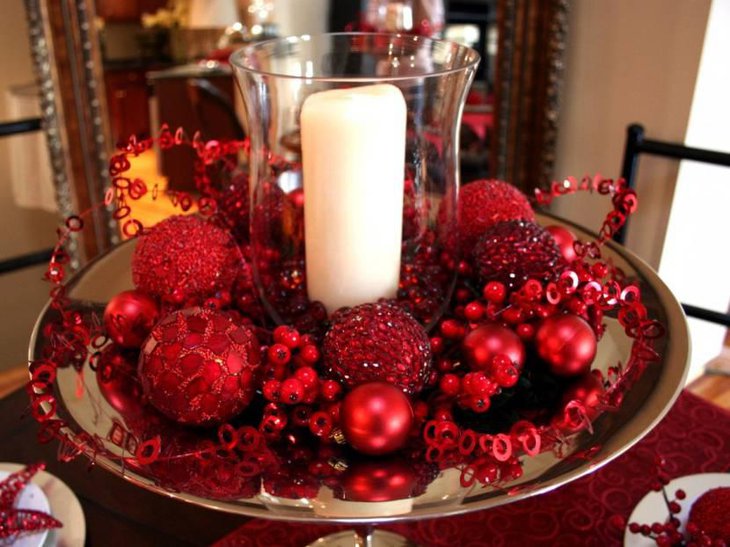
top-left (341, 460), bottom-right (416, 502)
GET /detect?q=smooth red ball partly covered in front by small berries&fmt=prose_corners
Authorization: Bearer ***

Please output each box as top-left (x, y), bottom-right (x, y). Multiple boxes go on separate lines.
top-left (461, 323), bottom-right (525, 370)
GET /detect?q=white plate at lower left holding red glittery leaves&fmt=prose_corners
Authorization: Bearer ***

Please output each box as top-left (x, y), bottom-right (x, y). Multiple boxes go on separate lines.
top-left (0, 463), bottom-right (86, 547)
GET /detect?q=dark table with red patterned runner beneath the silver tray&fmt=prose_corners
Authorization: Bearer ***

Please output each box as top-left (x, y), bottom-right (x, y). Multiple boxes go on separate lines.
top-left (0, 390), bottom-right (730, 547)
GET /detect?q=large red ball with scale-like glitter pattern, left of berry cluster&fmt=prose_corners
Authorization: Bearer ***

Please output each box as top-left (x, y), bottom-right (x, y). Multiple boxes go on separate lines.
top-left (139, 308), bottom-right (260, 425)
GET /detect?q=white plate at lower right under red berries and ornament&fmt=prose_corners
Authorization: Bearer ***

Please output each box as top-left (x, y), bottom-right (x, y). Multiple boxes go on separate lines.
top-left (624, 473), bottom-right (730, 547)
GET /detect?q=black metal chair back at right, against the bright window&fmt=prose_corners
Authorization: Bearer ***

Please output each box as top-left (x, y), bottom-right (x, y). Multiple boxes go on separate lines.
top-left (614, 124), bottom-right (730, 327)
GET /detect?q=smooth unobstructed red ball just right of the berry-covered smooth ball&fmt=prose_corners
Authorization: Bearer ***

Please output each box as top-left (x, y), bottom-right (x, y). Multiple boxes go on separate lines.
top-left (535, 314), bottom-right (598, 376)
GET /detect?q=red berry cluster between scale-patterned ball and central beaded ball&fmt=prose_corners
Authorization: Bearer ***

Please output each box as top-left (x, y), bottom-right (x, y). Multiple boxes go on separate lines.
top-left (259, 325), bottom-right (343, 439)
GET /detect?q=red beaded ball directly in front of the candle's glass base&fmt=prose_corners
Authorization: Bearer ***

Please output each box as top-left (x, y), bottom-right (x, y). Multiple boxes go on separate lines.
top-left (322, 304), bottom-right (431, 395)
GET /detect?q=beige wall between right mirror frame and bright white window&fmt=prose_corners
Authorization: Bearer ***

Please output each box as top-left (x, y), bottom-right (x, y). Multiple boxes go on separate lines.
top-left (554, 0), bottom-right (710, 267)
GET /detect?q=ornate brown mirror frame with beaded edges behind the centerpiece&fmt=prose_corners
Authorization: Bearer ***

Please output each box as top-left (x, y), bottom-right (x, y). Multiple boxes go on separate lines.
top-left (25, 0), bottom-right (570, 266)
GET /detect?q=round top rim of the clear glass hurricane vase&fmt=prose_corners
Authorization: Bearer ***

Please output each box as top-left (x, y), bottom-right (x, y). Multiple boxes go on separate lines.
top-left (228, 32), bottom-right (481, 83)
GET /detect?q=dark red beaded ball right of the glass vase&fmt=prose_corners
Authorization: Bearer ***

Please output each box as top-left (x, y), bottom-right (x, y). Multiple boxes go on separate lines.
top-left (474, 220), bottom-right (566, 289)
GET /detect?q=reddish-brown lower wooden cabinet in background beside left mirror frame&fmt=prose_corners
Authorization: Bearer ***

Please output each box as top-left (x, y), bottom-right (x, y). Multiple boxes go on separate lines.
top-left (104, 69), bottom-right (150, 144)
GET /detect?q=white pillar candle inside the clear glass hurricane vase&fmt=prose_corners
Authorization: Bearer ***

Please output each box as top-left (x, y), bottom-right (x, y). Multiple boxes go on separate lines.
top-left (301, 84), bottom-right (406, 313)
